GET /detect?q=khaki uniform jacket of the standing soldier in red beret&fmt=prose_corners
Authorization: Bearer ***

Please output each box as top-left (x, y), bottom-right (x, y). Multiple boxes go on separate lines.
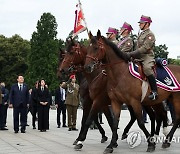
top-left (65, 83), bottom-right (79, 106)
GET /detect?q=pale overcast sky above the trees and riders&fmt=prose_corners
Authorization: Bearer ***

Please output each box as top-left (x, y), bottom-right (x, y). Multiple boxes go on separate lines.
top-left (0, 0), bottom-right (180, 58)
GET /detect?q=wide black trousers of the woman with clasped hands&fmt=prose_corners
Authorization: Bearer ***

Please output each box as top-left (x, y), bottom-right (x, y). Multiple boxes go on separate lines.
top-left (38, 105), bottom-right (49, 130)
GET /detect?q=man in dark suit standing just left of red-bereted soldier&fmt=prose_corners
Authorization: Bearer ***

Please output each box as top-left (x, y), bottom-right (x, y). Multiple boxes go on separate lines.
top-left (55, 81), bottom-right (67, 128)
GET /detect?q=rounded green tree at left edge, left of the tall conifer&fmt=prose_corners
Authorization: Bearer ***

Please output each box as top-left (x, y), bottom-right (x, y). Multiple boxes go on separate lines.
top-left (0, 34), bottom-right (30, 88)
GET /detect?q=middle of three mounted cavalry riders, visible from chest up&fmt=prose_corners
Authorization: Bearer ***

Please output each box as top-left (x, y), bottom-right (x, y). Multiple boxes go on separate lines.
top-left (118, 22), bottom-right (133, 52)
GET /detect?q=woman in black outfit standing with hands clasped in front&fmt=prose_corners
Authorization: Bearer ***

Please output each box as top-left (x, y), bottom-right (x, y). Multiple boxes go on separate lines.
top-left (38, 79), bottom-right (50, 132)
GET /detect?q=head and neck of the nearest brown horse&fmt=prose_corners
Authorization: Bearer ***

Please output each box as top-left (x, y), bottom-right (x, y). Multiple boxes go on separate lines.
top-left (84, 30), bottom-right (128, 73)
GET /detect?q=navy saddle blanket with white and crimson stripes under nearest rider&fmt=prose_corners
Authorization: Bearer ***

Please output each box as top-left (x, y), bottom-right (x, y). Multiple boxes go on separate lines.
top-left (129, 62), bottom-right (180, 92)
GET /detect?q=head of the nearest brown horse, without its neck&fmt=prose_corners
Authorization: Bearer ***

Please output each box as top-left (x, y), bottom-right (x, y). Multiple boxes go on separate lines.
top-left (84, 30), bottom-right (106, 73)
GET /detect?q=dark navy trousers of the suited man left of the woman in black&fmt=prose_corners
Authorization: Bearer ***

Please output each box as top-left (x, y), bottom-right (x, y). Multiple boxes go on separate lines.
top-left (13, 105), bottom-right (27, 131)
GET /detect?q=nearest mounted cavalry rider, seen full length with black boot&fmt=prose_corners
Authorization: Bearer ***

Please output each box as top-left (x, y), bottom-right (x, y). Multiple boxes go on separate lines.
top-left (128, 15), bottom-right (158, 100)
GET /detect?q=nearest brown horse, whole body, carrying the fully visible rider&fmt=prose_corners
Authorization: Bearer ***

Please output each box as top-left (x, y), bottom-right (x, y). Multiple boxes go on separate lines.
top-left (85, 31), bottom-right (180, 153)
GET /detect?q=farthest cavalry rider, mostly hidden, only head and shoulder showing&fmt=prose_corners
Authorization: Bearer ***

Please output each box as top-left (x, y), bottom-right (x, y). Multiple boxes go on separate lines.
top-left (106, 27), bottom-right (118, 44)
